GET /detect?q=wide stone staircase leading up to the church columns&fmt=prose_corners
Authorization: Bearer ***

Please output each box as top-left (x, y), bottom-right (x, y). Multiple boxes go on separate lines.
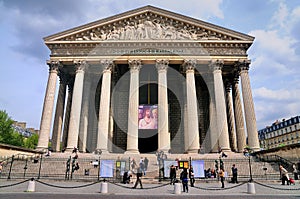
top-left (0, 152), bottom-right (280, 183)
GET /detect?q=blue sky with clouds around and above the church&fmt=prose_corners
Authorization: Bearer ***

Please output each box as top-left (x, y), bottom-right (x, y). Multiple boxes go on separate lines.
top-left (0, 0), bottom-right (300, 129)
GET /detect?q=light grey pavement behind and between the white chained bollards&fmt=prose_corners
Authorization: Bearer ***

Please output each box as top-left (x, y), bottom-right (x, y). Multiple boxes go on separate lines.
top-left (0, 179), bottom-right (300, 198)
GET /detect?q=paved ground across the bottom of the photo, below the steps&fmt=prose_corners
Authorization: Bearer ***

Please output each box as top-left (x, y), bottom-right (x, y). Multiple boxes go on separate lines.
top-left (0, 180), bottom-right (300, 199)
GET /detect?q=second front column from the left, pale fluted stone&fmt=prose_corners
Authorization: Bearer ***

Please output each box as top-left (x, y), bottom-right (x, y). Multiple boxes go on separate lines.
top-left (66, 61), bottom-right (87, 151)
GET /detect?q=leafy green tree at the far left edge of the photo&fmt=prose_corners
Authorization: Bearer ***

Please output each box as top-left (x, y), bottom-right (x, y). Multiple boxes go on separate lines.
top-left (0, 110), bottom-right (23, 146)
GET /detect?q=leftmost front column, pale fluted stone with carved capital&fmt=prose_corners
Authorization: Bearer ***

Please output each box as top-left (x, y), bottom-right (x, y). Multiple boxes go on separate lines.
top-left (37, 61), bottom-right (60, 149)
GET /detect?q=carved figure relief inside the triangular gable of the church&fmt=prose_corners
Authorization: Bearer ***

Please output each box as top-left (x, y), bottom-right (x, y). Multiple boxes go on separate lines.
top-left (75, 17), bottom-right (222, 41)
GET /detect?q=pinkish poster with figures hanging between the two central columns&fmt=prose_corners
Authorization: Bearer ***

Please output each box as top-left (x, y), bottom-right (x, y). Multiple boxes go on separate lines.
top-left (139, 105), bottom-right (158, 129)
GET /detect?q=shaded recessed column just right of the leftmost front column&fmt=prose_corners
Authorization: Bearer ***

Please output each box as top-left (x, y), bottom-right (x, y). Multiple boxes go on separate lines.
top-left (51, 73), bottom-right (67, 151)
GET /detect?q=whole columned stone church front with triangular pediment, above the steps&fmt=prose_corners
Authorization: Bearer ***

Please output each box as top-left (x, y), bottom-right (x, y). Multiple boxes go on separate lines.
top-left (38, 6), bottom-right (259, 154)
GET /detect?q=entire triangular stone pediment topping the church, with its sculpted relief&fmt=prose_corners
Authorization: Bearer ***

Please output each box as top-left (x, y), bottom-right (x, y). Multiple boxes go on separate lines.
top-left (44, 6), bottom-right (254, 43)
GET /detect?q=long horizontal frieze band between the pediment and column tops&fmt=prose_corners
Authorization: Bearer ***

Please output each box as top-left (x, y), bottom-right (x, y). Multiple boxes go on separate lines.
top-left (51, 43), bottom-right (247, 56)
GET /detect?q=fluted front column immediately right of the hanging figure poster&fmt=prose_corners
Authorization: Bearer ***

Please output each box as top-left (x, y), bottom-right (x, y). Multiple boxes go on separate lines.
top-left (156, 60), bottom-right (170, 152)
